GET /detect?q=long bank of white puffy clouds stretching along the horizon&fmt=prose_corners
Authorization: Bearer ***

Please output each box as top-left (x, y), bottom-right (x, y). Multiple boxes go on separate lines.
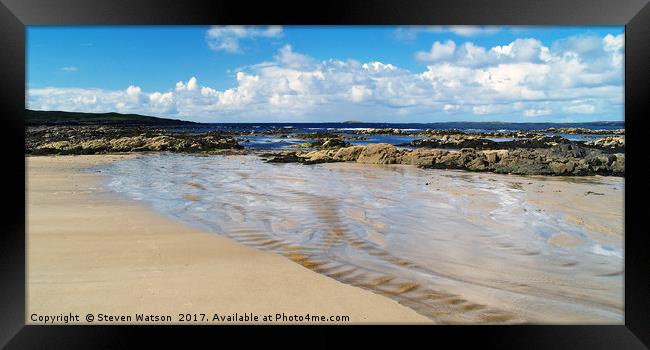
top-left (28, 35), bottom-right (623, 121)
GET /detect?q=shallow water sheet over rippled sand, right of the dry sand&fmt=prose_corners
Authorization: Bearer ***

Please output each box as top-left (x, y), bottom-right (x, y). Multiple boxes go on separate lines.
top-left (105, 154), bottom-right (624, 324)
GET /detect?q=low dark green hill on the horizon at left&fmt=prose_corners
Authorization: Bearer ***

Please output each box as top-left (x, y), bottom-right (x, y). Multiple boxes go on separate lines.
top-left (25, 109), bottom-right (199, 125)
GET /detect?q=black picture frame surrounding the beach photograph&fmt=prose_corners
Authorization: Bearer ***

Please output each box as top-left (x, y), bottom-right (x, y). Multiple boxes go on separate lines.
top-left (0, 0), bottom-right (650, 349)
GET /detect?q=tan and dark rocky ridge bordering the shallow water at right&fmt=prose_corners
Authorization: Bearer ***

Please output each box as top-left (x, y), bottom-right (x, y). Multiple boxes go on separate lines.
top-left (262, 143), bottom-right (625, 176)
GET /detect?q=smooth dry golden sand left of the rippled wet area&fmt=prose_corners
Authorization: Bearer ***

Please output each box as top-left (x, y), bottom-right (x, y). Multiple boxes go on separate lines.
top-left (26, 155), bottom-right (431, 324)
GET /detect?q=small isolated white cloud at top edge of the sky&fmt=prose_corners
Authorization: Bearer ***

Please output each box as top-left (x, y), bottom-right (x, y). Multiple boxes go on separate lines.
top-left (205, 26), bottom-right (283, 53)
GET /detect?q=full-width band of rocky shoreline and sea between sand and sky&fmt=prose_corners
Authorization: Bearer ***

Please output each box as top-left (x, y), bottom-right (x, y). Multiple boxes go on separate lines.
top-left (25, 125), bottom-right (625, 176)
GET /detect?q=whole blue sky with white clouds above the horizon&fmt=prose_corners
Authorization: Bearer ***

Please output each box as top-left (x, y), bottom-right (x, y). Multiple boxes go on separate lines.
top-left (25, 26), bottom-right (625, 123)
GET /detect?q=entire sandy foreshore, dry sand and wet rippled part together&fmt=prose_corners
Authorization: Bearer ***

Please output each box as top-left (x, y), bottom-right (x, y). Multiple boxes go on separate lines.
top-left (26, 152), bottom-right (624, 324)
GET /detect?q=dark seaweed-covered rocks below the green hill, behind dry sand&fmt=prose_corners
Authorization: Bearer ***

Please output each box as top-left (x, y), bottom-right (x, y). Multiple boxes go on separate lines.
top-left (25, 126), bottom-right (243, 155)
